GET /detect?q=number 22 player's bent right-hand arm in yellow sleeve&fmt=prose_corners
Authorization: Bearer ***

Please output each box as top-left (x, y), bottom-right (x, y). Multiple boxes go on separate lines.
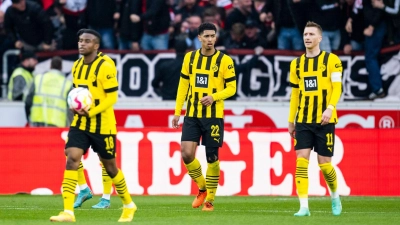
top-left (212, 56), bottom-right (236, 101)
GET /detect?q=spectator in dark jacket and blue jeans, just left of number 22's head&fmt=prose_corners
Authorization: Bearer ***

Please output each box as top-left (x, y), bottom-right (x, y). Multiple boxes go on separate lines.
top-left (130, 0), bottom-right (171, 50)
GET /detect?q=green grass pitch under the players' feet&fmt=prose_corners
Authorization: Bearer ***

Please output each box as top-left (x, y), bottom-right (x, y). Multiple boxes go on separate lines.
top-left (0, 195), bottom-right (400, 225)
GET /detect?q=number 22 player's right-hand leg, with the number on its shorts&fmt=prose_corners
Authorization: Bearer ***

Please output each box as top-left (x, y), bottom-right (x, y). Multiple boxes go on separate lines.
top-left (201, 118), bottom-right (224, 211)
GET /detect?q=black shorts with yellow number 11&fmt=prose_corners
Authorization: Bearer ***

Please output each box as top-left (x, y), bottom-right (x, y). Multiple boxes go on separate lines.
top-left (294, 123), bottom-right (335, 157)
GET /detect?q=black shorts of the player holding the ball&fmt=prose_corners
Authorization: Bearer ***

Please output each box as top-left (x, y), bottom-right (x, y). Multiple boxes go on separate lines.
top-left (65, 127), bottom-right (117, 159)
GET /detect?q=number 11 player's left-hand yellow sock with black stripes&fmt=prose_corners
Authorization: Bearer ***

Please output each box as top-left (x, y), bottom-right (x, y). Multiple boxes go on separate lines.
top-left (295, 158), bottom-right (308, 198)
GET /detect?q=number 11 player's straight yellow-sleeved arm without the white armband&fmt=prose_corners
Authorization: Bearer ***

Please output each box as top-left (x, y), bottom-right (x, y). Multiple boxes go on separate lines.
top-left (288, 59), bottom-right (300, 123)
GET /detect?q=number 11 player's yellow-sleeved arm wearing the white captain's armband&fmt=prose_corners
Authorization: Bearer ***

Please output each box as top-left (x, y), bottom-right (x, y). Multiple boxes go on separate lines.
top-left (328, 55), bottom-right (343, 109)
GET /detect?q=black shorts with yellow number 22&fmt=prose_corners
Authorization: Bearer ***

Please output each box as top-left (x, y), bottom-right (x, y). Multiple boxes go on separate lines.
top-left (181, 116), bottom-right (224, 147)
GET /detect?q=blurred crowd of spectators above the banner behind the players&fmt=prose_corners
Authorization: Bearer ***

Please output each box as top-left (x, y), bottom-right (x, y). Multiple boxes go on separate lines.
top-left (0, 0), bottom-right (400, 54)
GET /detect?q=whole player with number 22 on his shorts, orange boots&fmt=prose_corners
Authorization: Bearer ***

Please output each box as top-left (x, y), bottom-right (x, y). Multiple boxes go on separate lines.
top-left (172, 23), bottom-right (236, 211)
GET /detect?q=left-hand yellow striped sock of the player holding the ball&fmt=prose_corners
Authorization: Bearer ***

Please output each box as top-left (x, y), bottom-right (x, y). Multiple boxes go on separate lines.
top-left (62, 170), bottom-right (78, 212)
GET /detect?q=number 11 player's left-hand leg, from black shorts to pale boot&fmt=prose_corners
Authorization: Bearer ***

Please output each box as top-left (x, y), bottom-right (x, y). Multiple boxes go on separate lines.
top-left (294, 124), bottom-right (314, 216)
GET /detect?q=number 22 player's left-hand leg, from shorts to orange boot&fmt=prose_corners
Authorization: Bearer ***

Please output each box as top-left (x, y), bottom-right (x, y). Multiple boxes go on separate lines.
top-left (181, 117), bottom-right (207, 208)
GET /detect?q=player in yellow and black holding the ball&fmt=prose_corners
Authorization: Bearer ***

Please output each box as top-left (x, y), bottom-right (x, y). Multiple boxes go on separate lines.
top-left (50, 29), bottom-right (137, 222)
